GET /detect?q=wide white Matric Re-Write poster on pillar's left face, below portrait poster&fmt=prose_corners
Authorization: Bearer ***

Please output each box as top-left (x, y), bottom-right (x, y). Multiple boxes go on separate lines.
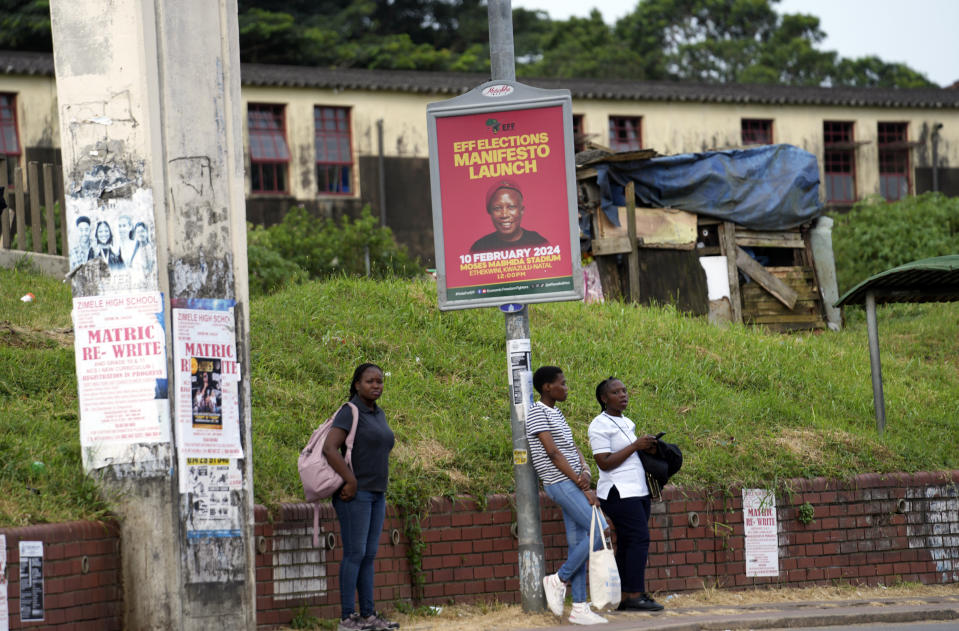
top-left (72, 291), bottom-right (170, 470)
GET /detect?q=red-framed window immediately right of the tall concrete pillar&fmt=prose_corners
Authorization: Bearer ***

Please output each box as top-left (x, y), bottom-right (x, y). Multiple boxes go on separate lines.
top-left (246, 103), bottom-right (290, 193)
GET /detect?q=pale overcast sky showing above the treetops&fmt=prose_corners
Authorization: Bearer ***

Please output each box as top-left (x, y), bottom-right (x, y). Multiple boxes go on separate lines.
top-left (512, 0), bottom-right (959, 86)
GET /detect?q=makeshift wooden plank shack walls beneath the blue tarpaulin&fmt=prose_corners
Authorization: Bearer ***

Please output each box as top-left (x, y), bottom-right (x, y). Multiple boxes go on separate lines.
top-left (577, 151), bottom-right (826, 331)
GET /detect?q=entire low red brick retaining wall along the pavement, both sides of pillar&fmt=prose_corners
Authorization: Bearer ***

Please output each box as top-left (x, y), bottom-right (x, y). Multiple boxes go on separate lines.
top-left (0, 471), bottom-right (959, 630)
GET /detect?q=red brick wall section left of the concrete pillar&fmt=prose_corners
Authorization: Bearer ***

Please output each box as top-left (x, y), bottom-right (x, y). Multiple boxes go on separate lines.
top-left (0, 521), bottom-right (123, 631)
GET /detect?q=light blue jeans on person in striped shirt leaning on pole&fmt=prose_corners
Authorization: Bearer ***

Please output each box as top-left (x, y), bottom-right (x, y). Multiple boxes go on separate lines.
top-left (544, 480), bottom-right (606, 603)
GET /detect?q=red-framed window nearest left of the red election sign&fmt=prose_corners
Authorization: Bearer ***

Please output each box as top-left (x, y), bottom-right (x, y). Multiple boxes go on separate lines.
top-left (313, 105), bottom-right (353, 195)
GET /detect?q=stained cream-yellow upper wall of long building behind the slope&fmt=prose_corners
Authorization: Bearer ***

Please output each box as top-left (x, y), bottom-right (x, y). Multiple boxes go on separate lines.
top-left (0, 75), bottom-right (959, 205)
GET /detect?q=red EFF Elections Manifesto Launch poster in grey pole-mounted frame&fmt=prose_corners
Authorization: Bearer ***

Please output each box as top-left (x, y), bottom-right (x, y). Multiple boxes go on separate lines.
top-left (435, 100), bottom-right (579, 308)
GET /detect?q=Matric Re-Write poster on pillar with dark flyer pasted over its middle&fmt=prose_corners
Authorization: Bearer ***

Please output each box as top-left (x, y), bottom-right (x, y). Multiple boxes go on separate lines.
top-left (171, 298), bottom-right (243, 458)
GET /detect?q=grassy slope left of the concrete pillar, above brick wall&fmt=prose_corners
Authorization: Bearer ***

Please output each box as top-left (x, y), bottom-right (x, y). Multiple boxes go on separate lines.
top-left (0, 268), bottom-right (107, 526)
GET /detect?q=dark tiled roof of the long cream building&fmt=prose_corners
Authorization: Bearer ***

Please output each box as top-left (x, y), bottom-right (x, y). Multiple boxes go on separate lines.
top-left (0, 51), bottom-right (959, 109)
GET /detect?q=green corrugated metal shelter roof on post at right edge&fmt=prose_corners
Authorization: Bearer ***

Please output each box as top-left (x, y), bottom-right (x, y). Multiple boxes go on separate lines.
top-left (836, 254), bottom-right (959, 307)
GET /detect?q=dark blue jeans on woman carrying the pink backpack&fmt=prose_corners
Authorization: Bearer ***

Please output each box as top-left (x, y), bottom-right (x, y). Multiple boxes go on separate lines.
top-left (333, 491), bottom-right (386, 619)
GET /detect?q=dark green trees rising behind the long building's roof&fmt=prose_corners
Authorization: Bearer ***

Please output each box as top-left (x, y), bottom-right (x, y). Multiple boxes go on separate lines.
top-left (0, 0), bottom-right (933, 88)
